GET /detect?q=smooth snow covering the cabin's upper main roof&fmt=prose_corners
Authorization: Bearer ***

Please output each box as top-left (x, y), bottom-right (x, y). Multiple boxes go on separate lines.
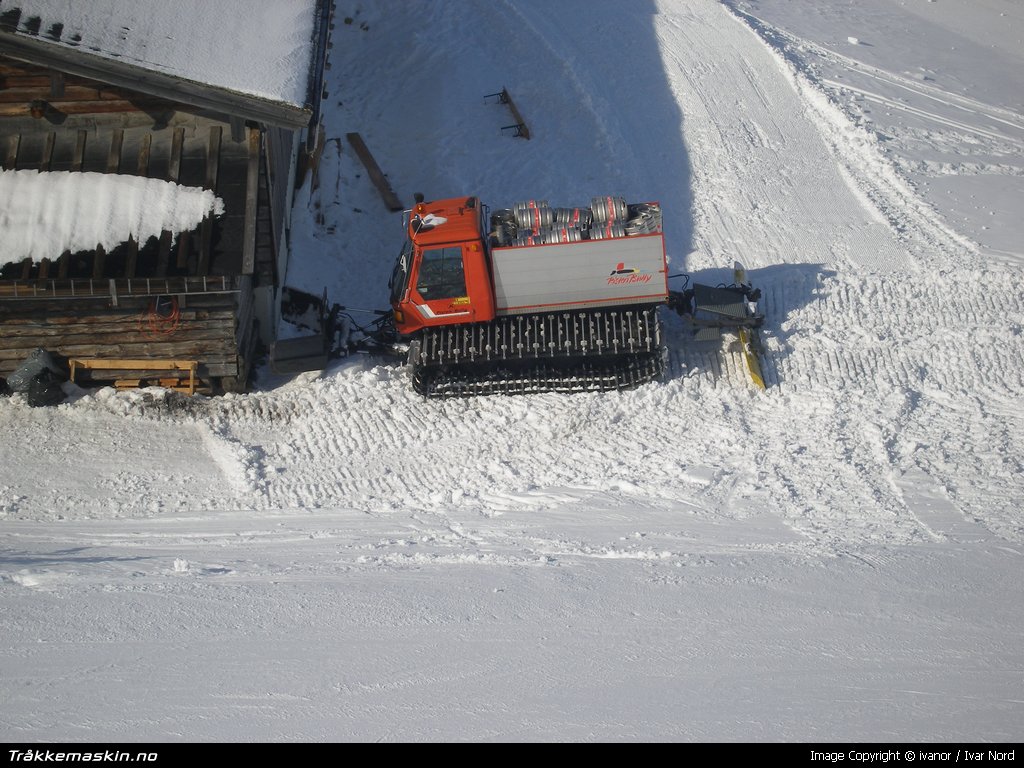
top-left (0, 0), bottom-right (317, 108)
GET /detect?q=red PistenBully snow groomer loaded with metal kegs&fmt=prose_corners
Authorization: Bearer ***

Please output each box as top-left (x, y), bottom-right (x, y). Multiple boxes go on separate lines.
top-left (389, 195), bottom-right (763, 396)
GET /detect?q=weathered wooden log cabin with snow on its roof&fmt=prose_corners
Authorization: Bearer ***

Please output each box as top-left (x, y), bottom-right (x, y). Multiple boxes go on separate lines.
top-left (0, 0), bottom-right (332, 391)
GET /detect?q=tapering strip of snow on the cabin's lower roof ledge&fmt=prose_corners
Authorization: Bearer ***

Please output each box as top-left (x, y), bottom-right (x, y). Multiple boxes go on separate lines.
top-left (0, 171), bottom-right (224, 265)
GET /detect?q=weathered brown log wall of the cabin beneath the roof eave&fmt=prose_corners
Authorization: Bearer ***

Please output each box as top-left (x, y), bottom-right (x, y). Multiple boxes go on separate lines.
top-left (0, 57), bottom-right (296, 390)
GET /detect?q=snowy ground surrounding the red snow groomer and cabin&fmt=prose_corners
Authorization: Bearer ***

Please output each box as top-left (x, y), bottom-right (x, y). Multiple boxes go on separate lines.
top-left (0, 0), bottom-right (1024, 741)
